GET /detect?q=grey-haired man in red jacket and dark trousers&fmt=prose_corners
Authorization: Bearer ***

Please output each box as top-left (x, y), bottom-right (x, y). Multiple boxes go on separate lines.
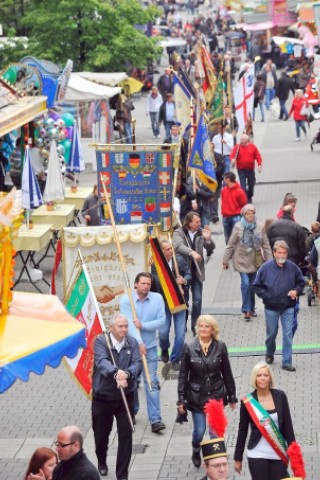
top-left (230, 133), bottom-right (262, 203)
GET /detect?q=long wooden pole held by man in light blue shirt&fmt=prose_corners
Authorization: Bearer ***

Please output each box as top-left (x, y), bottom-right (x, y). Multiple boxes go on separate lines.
top-left (100, 174), bottom-right (152, 391)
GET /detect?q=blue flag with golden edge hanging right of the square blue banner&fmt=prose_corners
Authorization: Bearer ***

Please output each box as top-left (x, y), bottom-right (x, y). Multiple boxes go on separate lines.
top-left (188, 115), bottom-right (218, 192)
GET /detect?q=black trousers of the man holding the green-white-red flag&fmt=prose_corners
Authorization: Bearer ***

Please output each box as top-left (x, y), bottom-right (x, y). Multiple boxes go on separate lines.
top-left (92, 392), bottom-right (133, 480)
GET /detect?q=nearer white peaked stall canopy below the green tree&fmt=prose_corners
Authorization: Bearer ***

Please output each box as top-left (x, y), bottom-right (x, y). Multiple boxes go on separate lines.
top-left (64, 73), bottom-right (121, 104)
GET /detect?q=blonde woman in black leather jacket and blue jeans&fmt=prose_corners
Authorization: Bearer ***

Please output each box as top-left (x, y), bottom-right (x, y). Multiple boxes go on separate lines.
top-left (177, 315), bottom-right (238, 467)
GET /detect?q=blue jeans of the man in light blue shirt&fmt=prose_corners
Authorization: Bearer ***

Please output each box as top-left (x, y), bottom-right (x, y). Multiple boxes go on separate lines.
top-left (142, 347), bottom-right (161, 425)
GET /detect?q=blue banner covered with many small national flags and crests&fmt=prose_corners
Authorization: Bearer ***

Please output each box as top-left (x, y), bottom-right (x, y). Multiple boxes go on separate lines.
top-left (96, 145), bottom-right (176, 231)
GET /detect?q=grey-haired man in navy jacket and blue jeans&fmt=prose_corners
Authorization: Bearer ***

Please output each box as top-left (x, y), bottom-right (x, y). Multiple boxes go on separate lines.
top-left (253, 240), bottom-right (305, 372)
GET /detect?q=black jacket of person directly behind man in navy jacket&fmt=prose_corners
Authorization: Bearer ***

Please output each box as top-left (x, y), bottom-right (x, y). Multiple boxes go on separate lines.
top-left (267, 212), bottom-right (307, 265)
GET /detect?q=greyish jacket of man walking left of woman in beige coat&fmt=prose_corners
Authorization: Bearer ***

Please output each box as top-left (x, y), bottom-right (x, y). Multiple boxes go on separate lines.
top-left (173, 228), bottom-right (216, 282)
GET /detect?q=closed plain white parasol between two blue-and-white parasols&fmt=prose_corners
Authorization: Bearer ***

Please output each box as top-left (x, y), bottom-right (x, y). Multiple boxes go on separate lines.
top-left (43, 140), bottom-right (64, 203)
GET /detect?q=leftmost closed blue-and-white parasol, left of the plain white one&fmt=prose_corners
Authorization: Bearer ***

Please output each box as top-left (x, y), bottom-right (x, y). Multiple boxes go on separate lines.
top-left (21, 146), bottom-right (43, 210)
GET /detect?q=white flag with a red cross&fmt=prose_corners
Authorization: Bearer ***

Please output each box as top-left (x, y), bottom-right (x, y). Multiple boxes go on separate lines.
top-left (233, 65), bottom-right (254, 134)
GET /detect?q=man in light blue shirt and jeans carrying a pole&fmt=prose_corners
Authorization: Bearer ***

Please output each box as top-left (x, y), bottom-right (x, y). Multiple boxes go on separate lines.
top-left (120, 272), bottom-right (166, 433)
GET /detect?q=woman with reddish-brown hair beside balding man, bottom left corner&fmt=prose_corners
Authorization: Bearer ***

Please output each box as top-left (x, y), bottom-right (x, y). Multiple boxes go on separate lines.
top-left (23, 447), bottom-right (58, 480)
